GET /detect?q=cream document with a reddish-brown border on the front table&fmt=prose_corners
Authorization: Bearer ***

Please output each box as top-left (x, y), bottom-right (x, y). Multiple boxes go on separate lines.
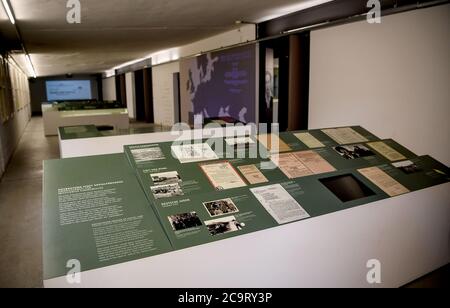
top-left (200, 162), bottom-right (247, 190)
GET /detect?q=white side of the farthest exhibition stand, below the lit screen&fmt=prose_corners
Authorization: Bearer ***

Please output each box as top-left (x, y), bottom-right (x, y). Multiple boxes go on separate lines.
top-left (42, 105), bottom-right (130, 136)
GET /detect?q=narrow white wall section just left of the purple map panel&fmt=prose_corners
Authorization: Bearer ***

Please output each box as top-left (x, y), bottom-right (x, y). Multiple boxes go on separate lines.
top-left (152, 62), bottom-right (180, 126)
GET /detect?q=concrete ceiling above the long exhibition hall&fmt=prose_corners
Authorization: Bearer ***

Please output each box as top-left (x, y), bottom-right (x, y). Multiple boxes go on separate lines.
top-left (0, 0), bottom-right (326, 76)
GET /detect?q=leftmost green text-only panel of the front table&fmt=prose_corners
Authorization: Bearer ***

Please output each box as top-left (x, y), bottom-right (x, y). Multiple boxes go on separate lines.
top-left (43, 154), bottom-right (171, 279)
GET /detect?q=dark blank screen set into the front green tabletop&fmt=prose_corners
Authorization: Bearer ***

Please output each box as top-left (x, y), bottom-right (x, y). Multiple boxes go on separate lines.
top-left (320, 174), bottom-right (375, 202)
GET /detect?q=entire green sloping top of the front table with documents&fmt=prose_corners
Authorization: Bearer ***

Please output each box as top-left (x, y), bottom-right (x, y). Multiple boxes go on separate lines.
top-left (44, 127), bottom-right (450, 279)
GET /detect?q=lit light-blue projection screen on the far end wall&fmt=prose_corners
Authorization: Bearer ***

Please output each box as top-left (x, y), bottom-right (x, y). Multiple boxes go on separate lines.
top-left (46, 80), bottom-right (92, 102)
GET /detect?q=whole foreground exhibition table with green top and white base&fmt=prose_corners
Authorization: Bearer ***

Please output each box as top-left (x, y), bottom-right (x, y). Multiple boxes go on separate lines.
top-left (43, 127), bottom-right (450, 288)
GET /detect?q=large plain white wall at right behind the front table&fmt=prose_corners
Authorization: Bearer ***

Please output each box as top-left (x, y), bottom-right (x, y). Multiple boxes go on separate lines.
top-left (309, 5), bottom-right (450, 165)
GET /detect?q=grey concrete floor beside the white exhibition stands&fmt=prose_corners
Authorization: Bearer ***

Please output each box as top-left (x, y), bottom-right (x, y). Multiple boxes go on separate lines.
top-left (0, 117), bottom-right (450, 288)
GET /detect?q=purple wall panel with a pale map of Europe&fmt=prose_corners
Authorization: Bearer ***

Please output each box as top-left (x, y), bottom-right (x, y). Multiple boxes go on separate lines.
top-left (180, 45), bottom-right (256, 124)
